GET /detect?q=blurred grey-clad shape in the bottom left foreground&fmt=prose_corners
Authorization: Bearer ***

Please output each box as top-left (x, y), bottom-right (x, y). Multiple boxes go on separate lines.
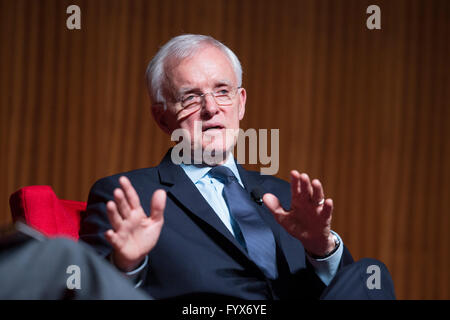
top-left (0, 222), bottom-right (151, 300)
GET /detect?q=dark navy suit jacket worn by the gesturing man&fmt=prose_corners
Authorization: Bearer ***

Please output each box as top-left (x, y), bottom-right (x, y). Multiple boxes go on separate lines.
top-left (80, 150), bottom-right (353, 299)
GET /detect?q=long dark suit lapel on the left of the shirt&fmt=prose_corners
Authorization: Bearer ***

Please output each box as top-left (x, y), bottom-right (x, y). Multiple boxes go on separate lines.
top-left (158, 149), bottom-right (248, 258)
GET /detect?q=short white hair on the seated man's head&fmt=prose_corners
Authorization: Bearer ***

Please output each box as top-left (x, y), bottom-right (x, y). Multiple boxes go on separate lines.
top-left (145, 34), bottom-right (242, 109)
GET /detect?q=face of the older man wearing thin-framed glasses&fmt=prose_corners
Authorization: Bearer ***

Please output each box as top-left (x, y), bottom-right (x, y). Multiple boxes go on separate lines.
top-left (157, 46), bottom-right (246, 159)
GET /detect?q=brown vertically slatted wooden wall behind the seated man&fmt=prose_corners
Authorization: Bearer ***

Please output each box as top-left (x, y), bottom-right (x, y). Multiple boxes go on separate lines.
top-left (0, 0), bottom-right (450, 299)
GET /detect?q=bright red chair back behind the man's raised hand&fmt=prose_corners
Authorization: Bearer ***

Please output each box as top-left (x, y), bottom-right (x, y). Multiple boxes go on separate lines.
top-left (9, 186), bottom-right (86, 241)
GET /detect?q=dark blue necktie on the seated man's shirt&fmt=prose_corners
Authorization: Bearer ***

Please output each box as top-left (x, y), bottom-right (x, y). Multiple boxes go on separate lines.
top-left (209, 166), bottom-right (278, 279)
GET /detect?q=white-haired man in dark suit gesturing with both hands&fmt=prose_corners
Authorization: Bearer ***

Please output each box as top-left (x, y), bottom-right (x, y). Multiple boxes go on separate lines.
top-left (80, 35), bottom-right (393, 299)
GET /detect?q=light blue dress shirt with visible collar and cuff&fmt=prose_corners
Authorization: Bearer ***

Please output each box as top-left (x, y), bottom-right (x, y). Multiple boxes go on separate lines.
top-left (180, 155), bottom-right (344, 285)
